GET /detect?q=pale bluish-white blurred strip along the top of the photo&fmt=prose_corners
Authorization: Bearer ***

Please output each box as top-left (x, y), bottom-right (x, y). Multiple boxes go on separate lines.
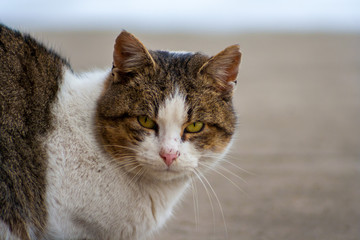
top-left (0, 0), bottom-right (360, 32)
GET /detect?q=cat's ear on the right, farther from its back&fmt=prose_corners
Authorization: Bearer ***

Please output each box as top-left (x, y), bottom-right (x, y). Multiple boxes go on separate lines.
top-left (199, 45), bottom-right (241, 92)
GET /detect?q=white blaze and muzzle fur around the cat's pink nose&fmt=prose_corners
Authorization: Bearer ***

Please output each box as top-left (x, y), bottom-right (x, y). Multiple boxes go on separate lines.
top-left (138, 91), bottom-right (200, 176)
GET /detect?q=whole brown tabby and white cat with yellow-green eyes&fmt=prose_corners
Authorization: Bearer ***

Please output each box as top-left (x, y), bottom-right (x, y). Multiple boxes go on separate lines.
top-left (0, 25), bottom-right (241, 240)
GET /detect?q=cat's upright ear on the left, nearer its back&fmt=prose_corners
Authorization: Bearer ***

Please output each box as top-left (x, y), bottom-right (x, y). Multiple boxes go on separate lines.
top-left (113, 31), bottom-right (155, 82)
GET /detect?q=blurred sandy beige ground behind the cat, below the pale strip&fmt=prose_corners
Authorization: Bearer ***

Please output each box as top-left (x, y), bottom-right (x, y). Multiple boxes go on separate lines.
top-left (31, 33), bottom-right (360, 240)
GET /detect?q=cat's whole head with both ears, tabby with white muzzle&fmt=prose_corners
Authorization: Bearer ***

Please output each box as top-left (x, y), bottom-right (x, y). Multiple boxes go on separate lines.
top-left (96, 31), bottom-right (241, 181)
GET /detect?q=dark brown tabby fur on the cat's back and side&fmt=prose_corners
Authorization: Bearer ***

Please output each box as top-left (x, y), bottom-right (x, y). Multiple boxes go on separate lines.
top-left (0, 24), bottom-right (66, 239)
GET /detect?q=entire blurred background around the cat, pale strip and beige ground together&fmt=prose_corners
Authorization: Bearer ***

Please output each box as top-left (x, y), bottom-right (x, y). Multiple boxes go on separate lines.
top-left (0, 0), bottom-right (360, 240)
